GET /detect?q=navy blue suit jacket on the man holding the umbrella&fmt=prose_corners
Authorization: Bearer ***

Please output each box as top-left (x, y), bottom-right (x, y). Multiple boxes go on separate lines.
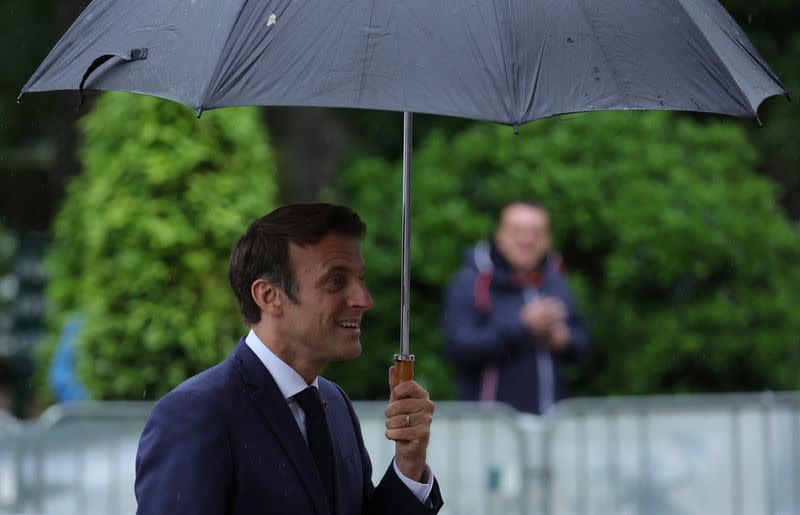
top-left (135, 338), bottom-right (442, 515)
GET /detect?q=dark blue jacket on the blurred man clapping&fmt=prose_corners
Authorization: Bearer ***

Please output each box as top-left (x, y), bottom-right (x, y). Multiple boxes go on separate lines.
top-left (442, 243), bottom-right (590, 414)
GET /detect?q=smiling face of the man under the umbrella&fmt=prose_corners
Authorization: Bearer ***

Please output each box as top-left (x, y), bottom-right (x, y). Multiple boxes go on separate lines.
top-left (280, 234), bottom-right (374, 366)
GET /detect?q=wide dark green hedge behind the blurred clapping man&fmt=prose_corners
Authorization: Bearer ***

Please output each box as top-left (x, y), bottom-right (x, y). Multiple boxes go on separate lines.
top-left (336, 112), bottom-right (800, 398)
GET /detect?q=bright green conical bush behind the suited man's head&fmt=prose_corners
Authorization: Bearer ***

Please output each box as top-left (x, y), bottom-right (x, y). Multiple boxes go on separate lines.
top-left (47, 93), bottom-right (276, 399)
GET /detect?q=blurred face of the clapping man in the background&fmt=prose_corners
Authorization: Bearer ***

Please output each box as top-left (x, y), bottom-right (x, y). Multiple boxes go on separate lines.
top-left (495, 204), bottom-right (550, 271)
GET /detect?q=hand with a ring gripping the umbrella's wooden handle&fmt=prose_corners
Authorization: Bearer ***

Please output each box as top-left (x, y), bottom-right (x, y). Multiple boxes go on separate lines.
top-left (386, 367), bottom-right (434, 483)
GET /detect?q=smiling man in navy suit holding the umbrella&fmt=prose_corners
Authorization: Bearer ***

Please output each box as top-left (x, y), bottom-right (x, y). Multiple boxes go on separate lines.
top-left (135, 204), bottom-right (442, 515)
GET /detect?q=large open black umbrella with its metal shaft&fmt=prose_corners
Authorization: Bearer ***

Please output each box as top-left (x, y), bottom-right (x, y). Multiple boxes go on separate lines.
top-left (21, 0), bottom-right (786, 378)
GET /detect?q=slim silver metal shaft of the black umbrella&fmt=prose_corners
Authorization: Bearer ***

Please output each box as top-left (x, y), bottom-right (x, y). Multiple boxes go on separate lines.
top-left (400, 111), bottom-right (412, 356)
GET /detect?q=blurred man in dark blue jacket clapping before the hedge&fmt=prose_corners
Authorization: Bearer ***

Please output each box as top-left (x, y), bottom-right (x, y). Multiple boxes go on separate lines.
top-left (443, 202), bottom-right (590, 414)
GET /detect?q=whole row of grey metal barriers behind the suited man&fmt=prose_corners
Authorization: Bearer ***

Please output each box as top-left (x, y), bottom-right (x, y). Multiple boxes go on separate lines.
top-left (0, 393), bottom-right (800, 515)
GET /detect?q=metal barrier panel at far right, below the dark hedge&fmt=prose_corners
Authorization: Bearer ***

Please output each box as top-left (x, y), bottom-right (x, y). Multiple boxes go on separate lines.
top-left (546, 393), bottom-right (800, 515)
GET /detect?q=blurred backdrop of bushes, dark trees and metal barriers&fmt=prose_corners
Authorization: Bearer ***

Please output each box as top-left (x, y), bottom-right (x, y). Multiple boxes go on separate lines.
top-left (0, 0), bottom-right (800, 515)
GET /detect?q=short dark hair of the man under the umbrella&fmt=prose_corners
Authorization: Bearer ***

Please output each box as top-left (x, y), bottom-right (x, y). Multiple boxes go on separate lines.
top-left (228, 203), bottom-right (367, 324)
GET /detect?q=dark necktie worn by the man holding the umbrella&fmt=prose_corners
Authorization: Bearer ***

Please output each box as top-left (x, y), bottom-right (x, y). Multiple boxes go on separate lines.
top-left (294, 386), bottom-right (335, 513)
